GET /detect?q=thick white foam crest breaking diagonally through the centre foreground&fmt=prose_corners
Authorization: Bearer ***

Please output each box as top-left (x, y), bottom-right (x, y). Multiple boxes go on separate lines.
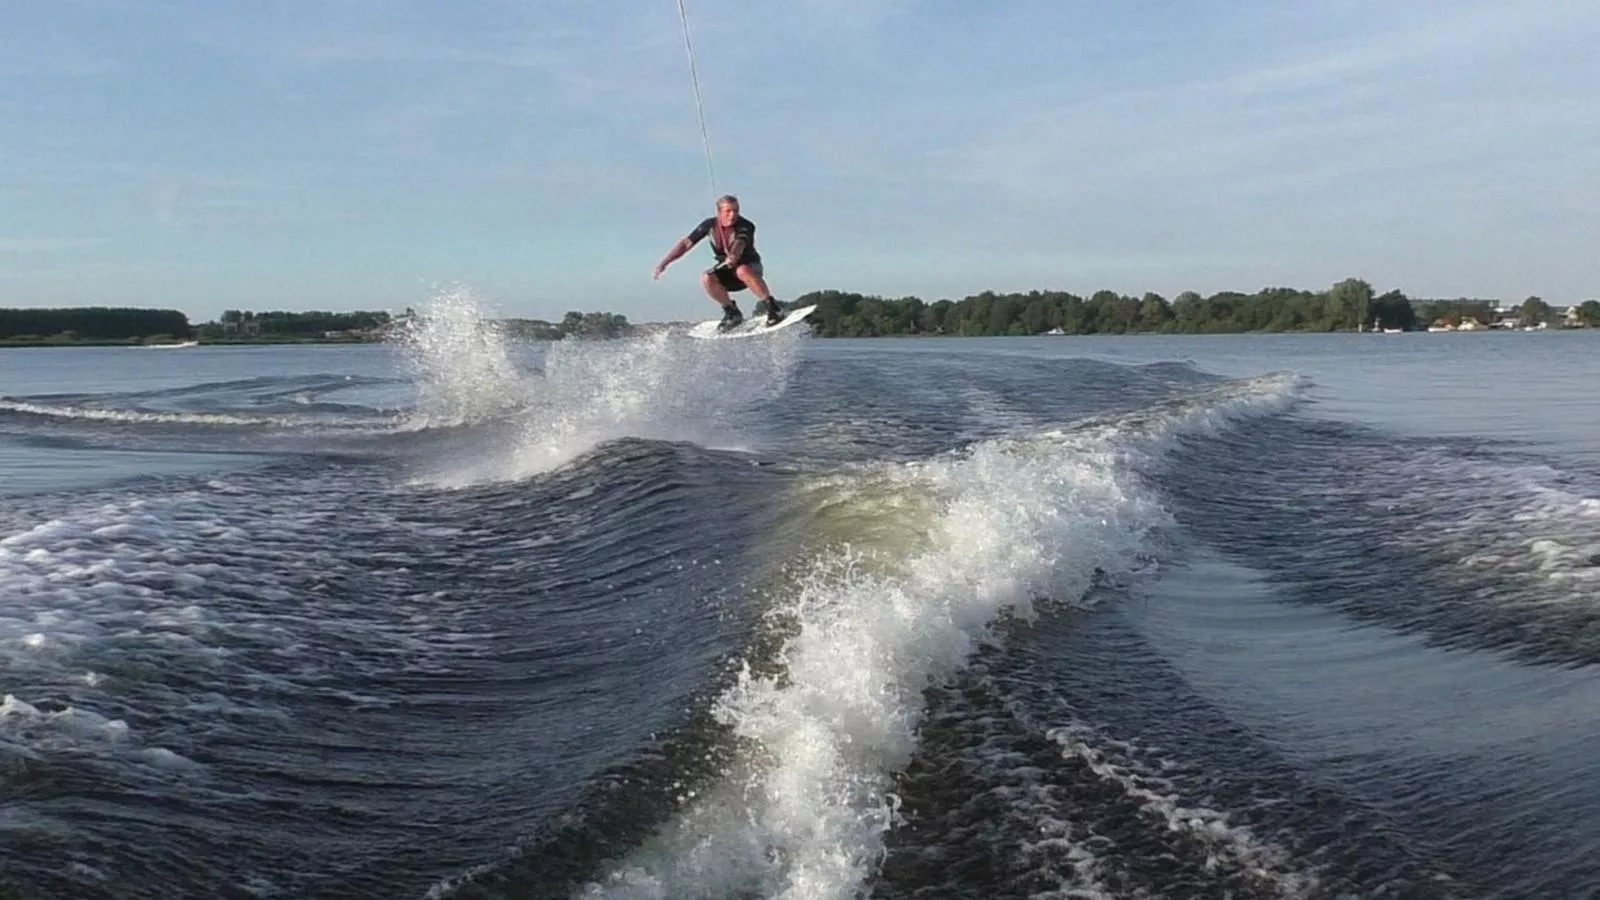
top-left (584, 373), bottom-right (1288, 900)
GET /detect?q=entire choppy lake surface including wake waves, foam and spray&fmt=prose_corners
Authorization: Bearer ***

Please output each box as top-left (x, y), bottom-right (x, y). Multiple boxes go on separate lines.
top-left (0, 298), bottom-right (1600, 900)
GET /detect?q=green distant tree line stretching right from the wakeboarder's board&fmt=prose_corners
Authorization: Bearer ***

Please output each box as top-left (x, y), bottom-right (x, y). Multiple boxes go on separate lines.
top-left (794, 279), bottom-right (1600, 338)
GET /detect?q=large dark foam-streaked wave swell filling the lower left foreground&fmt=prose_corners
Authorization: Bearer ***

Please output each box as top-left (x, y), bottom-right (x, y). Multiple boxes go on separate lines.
top-left (0, 440), bottom-right (793, 897)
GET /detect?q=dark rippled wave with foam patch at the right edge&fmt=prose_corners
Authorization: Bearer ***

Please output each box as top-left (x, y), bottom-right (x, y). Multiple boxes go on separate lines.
top-left (1168, 409), bottom-right (1600, 665)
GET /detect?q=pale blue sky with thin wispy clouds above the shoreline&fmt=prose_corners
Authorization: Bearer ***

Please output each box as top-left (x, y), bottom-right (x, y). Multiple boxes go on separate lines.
top-left (0, 0), bottom-right (1600, 320)
